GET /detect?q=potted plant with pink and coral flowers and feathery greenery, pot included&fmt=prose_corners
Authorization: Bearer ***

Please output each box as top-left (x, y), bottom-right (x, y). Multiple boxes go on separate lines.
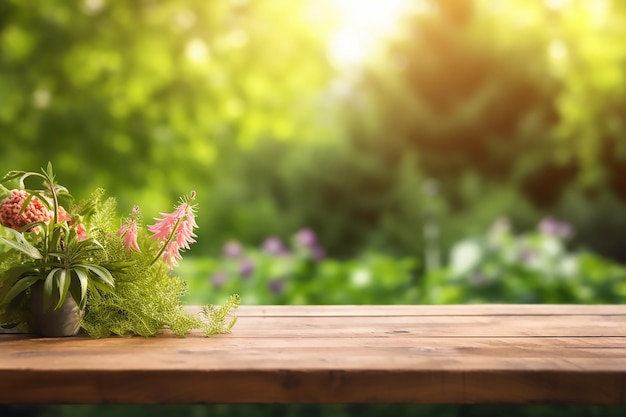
top-left (0, 164), bottom-right (238, 337)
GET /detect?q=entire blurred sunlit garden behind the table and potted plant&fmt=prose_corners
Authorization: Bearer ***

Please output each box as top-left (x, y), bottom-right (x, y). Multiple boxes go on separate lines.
top-left (0, 0), bottom-right (626, 416)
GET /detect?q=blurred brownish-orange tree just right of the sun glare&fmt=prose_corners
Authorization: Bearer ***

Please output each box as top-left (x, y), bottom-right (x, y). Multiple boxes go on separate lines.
top-left (363, 0), bottom-right (564, 208)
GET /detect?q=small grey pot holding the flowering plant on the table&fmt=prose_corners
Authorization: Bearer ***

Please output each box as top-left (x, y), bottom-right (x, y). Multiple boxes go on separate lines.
top-left (30, 281), bottom-right (82, 337)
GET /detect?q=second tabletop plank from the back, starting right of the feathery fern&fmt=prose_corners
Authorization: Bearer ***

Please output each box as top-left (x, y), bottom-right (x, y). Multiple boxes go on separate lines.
top-left (197, 315), bottom-right (626, 338)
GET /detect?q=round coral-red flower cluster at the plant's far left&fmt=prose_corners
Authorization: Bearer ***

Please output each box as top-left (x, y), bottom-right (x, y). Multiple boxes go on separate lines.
top-left (0, 190), bottom-right (52, 231)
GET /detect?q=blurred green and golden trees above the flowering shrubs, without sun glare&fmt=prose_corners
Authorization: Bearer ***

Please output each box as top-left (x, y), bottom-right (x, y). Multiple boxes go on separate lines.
top-left (0, 0), bottom-right (626, 257)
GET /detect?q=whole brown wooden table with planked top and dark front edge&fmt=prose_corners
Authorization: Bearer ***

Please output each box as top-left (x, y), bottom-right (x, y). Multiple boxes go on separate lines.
top-left (0, 305), bottom-right (626, 404)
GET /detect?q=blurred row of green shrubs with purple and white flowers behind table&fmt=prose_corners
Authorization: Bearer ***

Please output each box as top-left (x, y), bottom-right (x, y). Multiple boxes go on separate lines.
top-left (179, 218), bottom-right (626, 305)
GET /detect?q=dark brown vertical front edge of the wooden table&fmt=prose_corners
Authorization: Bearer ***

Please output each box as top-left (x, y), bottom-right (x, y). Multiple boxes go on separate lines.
top-left (0, 370), bottom-right (624, 405)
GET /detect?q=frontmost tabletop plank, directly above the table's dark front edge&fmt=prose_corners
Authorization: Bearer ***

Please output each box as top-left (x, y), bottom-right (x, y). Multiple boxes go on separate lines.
top-left (0, 336), bottom-right (626, 371)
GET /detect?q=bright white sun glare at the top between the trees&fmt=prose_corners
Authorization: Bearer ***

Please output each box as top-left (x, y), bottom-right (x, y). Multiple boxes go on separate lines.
top-left (329, 0), bottom-right (411, 68)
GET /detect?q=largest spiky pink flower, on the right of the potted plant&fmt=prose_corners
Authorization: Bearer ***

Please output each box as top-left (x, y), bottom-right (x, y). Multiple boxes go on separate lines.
top-left (148, 191), bottom-right (198, 268)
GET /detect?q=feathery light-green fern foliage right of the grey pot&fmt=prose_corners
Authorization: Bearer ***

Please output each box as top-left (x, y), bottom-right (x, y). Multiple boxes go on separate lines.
top-left (73, 192), bottom-right (239, 337)
